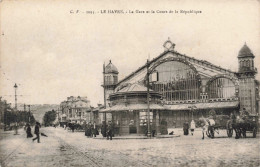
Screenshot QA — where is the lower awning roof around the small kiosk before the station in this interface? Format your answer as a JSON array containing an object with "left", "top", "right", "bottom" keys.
[{"left": 100, "top": 104, "right": 165, "bottom": 113}]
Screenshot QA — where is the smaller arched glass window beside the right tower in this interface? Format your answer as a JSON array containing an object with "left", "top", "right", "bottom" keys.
[{"left": 208, "top": 77, "right": 236, "bottom": 98}]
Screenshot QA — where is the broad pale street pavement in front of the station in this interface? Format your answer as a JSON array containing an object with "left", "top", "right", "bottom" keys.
[{"left": 0, "top": 127, "right": 260, "bottom": 167}]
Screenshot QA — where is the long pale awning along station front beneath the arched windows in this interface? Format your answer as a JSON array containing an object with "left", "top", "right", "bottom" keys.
[{"left": 164, "top": 101, "right": 239, "bottom": 110}]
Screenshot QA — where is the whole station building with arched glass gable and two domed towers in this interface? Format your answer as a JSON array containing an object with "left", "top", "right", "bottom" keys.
[{"left": 101, "top": 40, "right": 259, "bottom": 134}]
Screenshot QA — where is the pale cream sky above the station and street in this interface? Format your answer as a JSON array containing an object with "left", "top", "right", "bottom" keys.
[{"left": 0, "top": 0, "right": 260, "bottom": 106}]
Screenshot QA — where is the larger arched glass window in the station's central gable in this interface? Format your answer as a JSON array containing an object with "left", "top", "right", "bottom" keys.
[{"left": 149, "top": 61, "right": 199, "bottom": 101}]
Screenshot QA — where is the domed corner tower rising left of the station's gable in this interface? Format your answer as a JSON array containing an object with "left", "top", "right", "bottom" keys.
[{"left": 102, "top": 60, "right": 118, "bottom": 107}]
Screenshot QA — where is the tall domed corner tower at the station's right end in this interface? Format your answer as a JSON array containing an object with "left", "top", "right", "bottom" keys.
[{"left": 237, "top": 44, "right": 258, "bottom": 114}]
